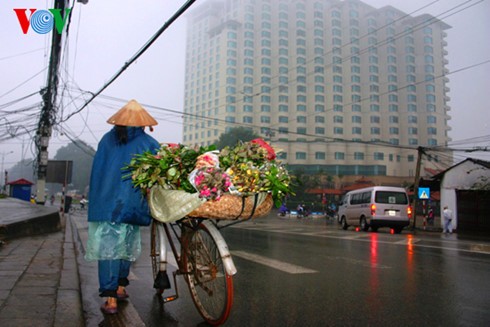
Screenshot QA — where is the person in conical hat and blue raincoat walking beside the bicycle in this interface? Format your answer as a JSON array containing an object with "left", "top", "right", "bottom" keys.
[{"left": 85, "top": 100, "right": 159, "bottom": 314}]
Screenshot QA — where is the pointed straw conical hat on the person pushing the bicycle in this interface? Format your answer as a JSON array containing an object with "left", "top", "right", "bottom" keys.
[{"left": 107, "top": 100, "right": 158, "bottom": 126}]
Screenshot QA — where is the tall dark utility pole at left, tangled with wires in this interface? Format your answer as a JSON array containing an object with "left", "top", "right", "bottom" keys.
[{"left": 35, "top": 0, "right": 68, "bottom": 204}]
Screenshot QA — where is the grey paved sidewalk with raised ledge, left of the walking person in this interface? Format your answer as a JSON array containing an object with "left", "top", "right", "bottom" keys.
[{"left": 0, "top": 198, "right": 84, "bottom": 327}]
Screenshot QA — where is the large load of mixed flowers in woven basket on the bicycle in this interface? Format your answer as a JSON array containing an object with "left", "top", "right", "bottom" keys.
[{"left": 125, "top": 139, "right": 292, "bottom": 222}]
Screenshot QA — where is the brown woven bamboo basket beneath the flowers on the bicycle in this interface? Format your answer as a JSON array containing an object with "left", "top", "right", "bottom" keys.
[{"left": 187, "top": 193, "right": 273, "bottom": 220}]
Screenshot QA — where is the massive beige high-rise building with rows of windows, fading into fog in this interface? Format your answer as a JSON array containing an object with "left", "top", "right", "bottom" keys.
[{"left": 183, "top": 0, "right": 450, "bottom": 183}]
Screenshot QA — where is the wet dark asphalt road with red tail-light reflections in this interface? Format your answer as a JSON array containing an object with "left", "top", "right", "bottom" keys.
[{"left": 72, "top": 217, "right": 490, "bottom": 326}]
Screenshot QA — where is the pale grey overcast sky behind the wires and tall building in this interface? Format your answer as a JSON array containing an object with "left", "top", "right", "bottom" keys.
[{"left": 0, "top": 0, "right": 490, "bottom": 168}]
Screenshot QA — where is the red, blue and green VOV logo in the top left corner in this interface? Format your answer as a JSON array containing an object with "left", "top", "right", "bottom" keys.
[{"left": 14, "top": 8, "right": 71, "bottom": 34}]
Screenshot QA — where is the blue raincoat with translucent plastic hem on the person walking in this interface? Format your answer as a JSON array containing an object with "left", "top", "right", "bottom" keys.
[{"left": 85, "top": 127, "right": 160, "bottom": 261}]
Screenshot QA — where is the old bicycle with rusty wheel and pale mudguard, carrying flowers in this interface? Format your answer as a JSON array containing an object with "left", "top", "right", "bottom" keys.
[{"left": 150, "top": 192, "right": 272, "bottom": 326}]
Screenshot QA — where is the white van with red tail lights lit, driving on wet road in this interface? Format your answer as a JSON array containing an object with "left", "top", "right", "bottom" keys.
[{"left": 338, "top": 186, "right": 412, "bottom": 233}]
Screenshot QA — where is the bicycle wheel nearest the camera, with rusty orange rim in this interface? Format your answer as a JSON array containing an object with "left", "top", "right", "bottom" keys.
[{"left": 182, "top": 223, "right": 233, "bottom": 326}]
